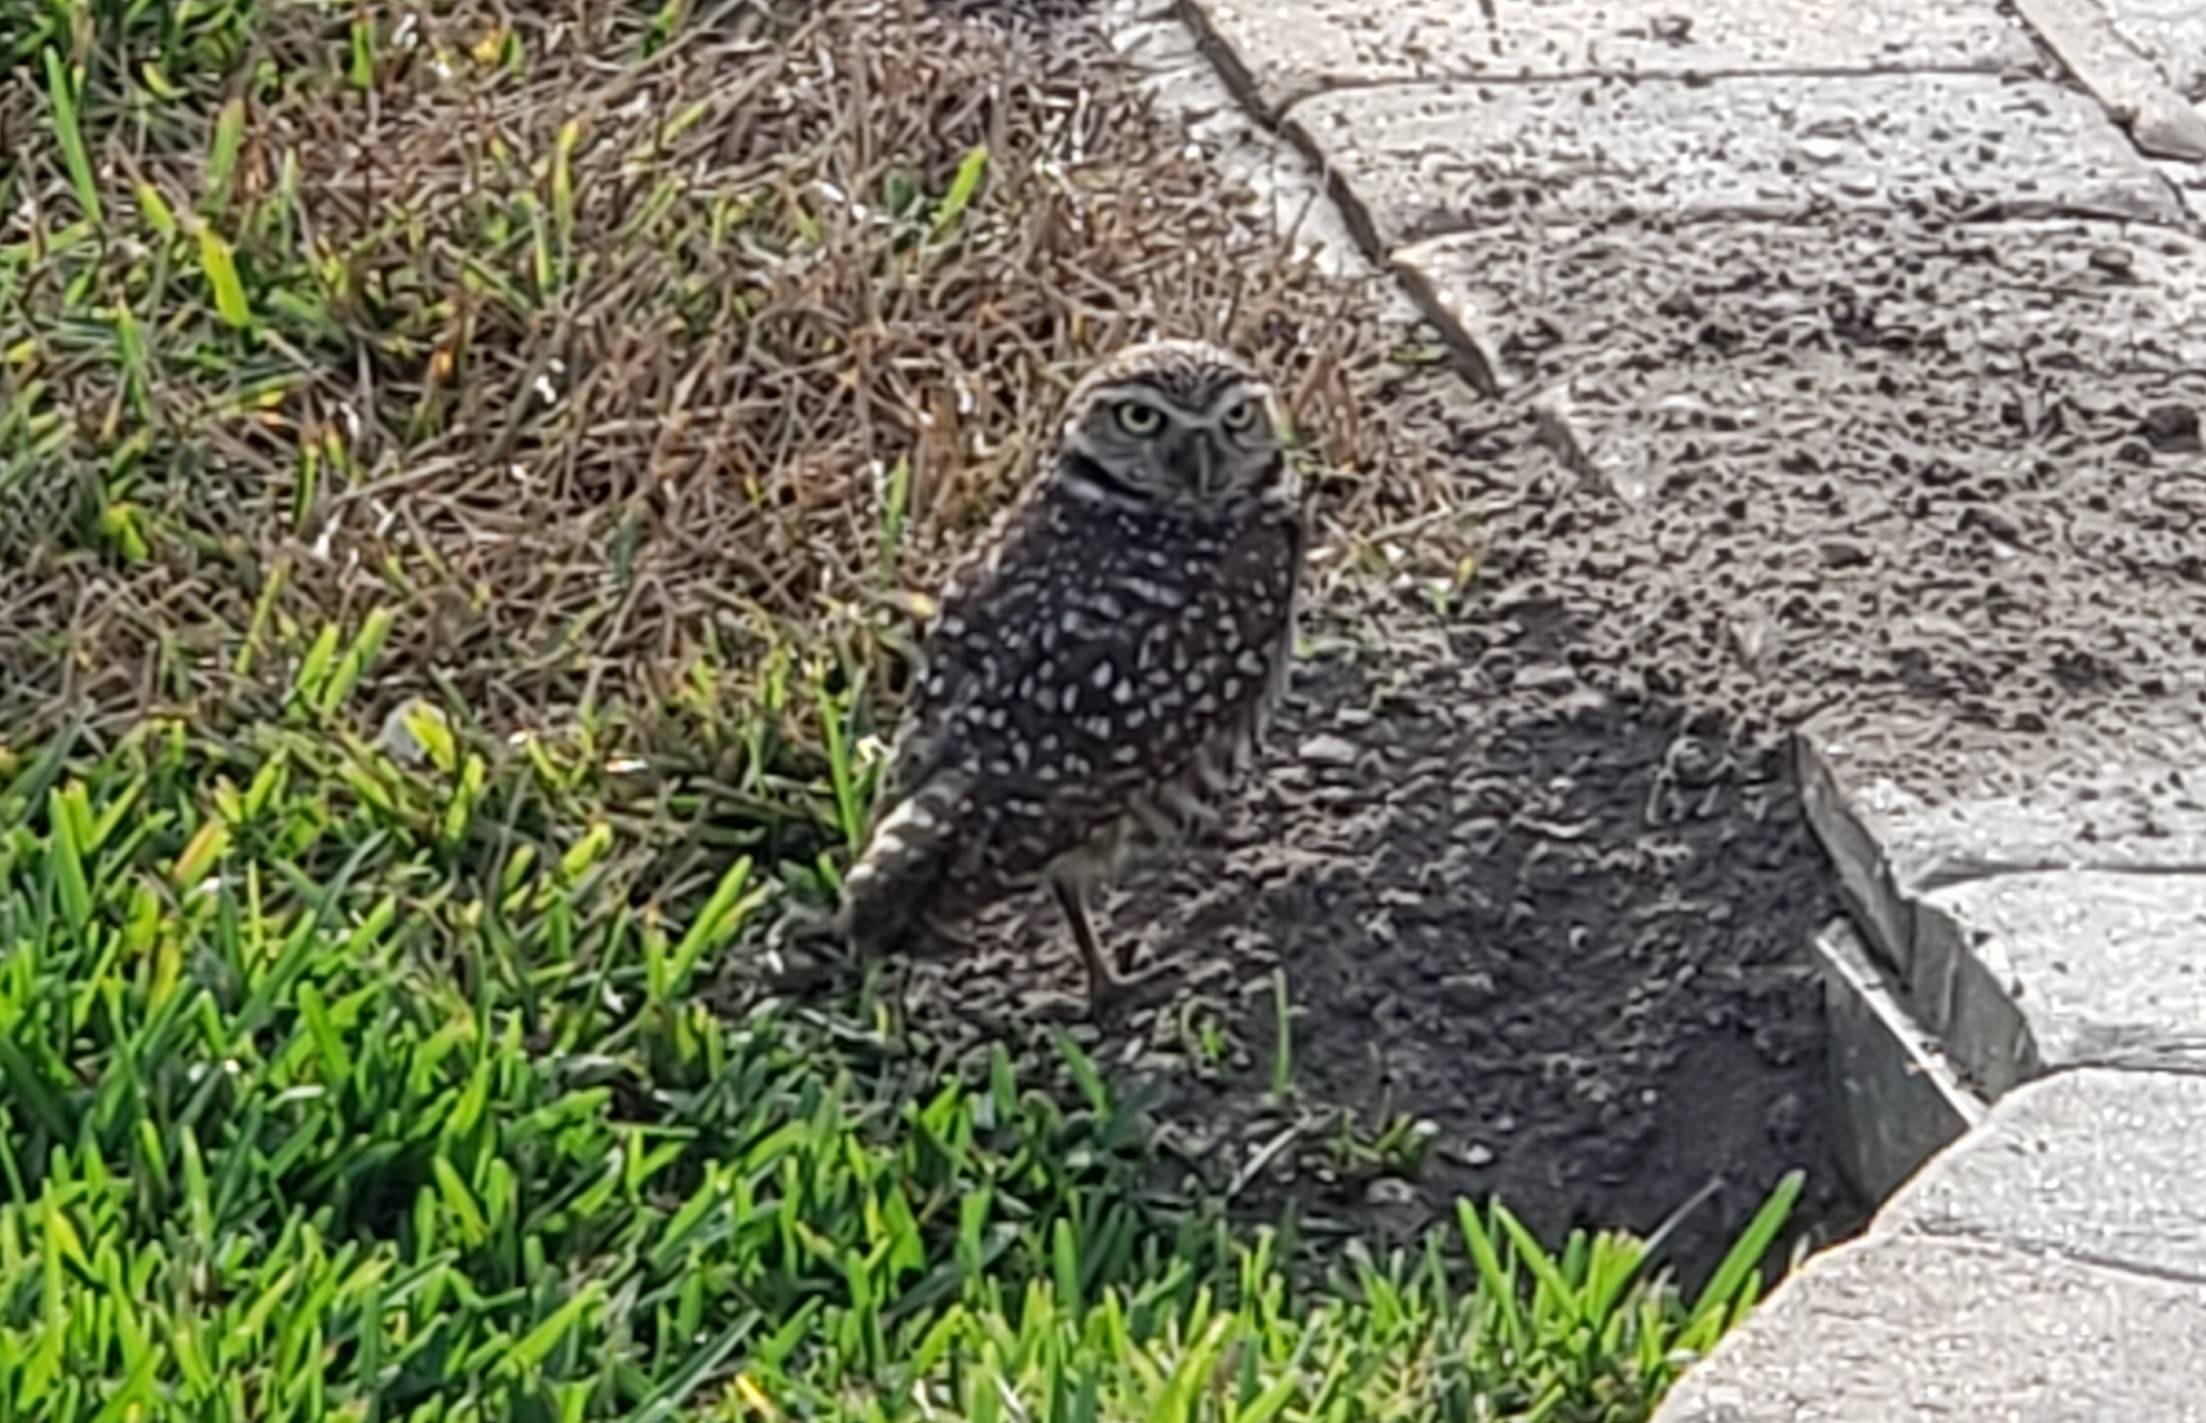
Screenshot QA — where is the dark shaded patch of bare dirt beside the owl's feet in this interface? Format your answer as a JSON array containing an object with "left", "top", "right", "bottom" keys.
[{"left": 895, "top": 582, "right": 1855, "bottom": 1280}]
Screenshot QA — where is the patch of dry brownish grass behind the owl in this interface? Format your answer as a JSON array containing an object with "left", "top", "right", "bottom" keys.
[{"left": 0, "top": 0, "right": 1464, "bottom": 842}]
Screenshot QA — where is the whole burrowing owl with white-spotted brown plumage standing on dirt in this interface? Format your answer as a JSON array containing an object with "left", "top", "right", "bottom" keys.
[{"left": 840, "top": 340, "right": 1306, "bottom": 1006}]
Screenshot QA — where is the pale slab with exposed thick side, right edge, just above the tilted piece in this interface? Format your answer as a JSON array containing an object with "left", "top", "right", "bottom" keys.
[{"left": 1908, "top": 871, "right": 2206, "bottom": 1096}]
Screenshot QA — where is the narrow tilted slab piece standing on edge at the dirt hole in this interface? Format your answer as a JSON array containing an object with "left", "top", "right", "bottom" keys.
[{"left": 1816, "top": 920, "right": 1983, "bottom": 1200}]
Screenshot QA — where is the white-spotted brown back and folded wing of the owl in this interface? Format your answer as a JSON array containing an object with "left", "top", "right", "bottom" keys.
[{"left": 845, "top": 476, "right": 1302, "bottom": 944}]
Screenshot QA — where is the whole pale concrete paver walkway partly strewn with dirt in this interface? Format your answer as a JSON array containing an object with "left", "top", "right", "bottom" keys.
[{"left": 1147, "top": 0, "right": 2206, "bottom": 1423}]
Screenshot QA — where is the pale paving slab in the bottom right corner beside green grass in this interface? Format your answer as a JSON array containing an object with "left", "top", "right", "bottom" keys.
[{"left": 1655, "top": 1233, "right": 2206, "bottom": 1423}]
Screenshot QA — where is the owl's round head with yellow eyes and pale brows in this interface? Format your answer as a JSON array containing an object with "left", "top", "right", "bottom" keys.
[{"left": 1061, "top": 340, "right": 1284, "bottom": 503}]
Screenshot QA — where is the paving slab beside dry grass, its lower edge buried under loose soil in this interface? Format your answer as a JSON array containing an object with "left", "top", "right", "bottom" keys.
[{"left": 1394, "top": 216, "right": 2206, "bottom": 401}]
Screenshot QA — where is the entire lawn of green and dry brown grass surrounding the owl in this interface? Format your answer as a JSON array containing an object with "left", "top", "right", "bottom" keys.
[{"left": 0, "top": 0, "right": 1798, "bottom": 1423}]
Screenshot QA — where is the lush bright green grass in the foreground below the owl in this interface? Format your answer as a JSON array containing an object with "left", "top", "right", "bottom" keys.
[{"left": 0, "top": 697, "right": 1796, "bottom": 1423}]
